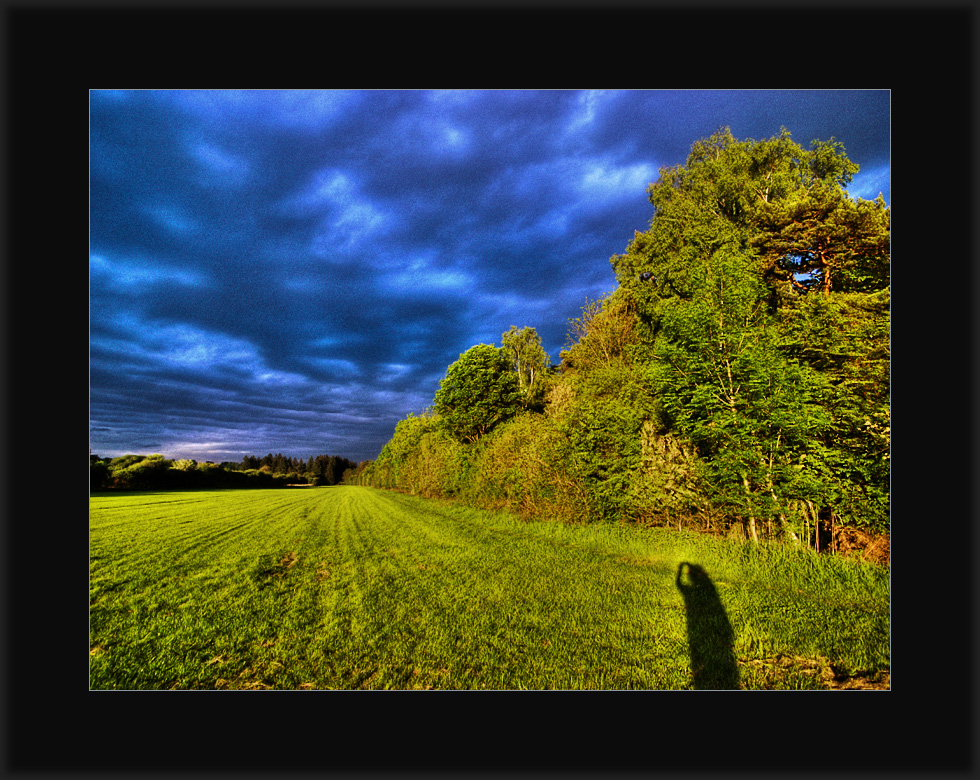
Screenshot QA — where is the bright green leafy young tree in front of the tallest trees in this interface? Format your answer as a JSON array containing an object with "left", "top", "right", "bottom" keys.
[{"left": 651, "top": 250, "right": 829, "bottom": 535}]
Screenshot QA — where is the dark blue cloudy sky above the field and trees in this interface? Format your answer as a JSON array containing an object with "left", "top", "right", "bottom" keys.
[{"left": 89, "top": 90, "right": 891, "bottom": 462}]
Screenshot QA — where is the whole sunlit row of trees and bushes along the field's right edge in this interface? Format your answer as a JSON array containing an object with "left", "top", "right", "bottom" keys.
[{"left": 349, "top": 128, "right": 890, "bottom": 548}]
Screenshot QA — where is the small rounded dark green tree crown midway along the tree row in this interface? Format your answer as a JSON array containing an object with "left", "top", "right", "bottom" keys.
[{"left": 434, "top": 344, "right": 521, "bottom": 442}]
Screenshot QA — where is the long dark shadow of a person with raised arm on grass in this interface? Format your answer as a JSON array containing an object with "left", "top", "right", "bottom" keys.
[{"left": 677, "top": 563, "right": 738, "bottom": 690}]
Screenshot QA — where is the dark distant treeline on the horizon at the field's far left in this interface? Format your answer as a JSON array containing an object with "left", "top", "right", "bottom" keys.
[{"left": 89, "top": 452, "right": 358, "bottom": 490}]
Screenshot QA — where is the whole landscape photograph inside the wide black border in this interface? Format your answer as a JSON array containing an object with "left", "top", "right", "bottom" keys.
[{"left": 83, "top": 88, "right": 892, "bottom": 692}]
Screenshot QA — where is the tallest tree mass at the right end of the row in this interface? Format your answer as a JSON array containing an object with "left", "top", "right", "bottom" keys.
[{"left": 612, "top": 128, "right": 890, "bottom": 536}]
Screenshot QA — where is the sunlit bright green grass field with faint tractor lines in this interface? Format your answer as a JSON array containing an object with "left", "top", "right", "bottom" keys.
[{"left": 90, "top": 487, "right": 890, "bottom": 689}]
